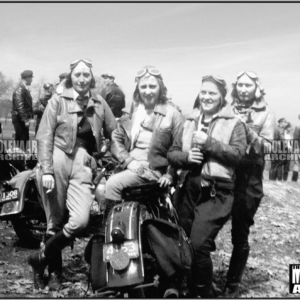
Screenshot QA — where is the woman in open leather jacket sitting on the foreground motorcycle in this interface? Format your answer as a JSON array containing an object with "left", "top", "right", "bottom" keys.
[{"left": 100, "top": 66, "right": 183, "bottom": 236}]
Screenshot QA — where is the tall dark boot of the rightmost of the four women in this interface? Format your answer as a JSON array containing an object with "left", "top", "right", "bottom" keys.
[{"left": 223, "top": 246, "right": 250, "bottom": 298}]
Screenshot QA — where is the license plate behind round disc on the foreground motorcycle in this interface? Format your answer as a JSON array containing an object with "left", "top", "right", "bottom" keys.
[{"left": 103, "top": 240, "right": 139, "bottom": 262}]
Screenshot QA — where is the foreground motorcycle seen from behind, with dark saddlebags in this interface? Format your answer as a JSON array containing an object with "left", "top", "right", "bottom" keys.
[{"left": 85, "top": 182, "right": 193, "bottom": 298}]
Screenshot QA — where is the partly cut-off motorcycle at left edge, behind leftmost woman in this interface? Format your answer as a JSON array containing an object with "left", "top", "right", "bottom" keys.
[{"left": 0, "top": 141, "right": 42, "bottom": 245}]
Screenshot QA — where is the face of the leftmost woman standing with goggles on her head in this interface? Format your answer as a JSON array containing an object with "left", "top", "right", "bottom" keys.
[{"left": 71, "top": 62, "right": 93, "bottom": 95}]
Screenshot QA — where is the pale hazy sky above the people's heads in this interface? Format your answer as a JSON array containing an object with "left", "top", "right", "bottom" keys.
[{"left": 0, "top": 3, "right": 300, "bottom": 124}]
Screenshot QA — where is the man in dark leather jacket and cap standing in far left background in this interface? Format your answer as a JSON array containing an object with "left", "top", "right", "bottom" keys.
[{"left": 11, "top": 70, "right": 33, "bottom": 151}]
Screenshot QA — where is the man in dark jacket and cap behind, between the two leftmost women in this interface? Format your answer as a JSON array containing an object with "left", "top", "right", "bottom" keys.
[{"left": 101, "top": 73, "right": 125, "bottom": 118}]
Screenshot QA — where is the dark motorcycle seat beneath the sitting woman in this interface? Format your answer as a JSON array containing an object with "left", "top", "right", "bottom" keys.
[{"left": 122, "top": 181, "right": 166, "bottom": 200}]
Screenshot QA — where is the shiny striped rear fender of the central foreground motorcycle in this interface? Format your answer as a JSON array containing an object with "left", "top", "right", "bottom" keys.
[{"left": 106, "top": 202, "right": 150, "bottom": 287}]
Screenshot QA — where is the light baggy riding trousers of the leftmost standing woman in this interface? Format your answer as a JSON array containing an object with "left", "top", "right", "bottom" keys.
[{"left": 37, "top": 146, "right": 94, "bottom": 237}]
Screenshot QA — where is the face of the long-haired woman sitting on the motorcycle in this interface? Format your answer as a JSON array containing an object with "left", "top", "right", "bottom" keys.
[{"left": 138, "top": 74, "right": 160, "bottom": 109}]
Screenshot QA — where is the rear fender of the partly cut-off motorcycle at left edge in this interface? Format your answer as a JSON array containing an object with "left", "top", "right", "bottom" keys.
[{"left": 0, "top": 170, "right": 34, "bottom": 220}]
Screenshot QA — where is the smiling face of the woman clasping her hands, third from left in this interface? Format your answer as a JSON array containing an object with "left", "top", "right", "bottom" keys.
[{"left": 199, "top": 81, "right": 222, "bottom": 115}]
